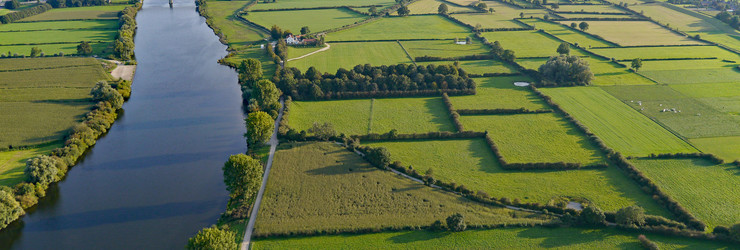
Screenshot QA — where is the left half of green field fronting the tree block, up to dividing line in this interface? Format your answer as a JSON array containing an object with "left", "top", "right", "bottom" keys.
[{"left": 288, "top": 99, "right": 371, "bottom": 135}]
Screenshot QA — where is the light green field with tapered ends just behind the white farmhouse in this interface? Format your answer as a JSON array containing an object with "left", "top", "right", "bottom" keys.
[{"left": 244, "top": 9, "right": 367, "bottom": 34}]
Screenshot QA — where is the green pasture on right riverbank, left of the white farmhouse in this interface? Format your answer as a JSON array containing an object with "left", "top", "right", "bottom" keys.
[{"left": 206, "top": 1, "right": 268, "bottom": 50}]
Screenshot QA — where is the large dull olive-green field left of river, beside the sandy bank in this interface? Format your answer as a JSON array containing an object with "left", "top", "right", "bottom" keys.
[{"left": 0, "top": 58, "right": 108, "bottom": 148}]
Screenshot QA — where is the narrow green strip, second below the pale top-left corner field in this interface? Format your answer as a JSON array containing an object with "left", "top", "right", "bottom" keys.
[{"left": 0, "top": 30, "right": 118, "bottom": 46}]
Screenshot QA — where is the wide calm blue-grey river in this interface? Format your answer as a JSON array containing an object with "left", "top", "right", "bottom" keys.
[{"left": 0, "top": 0, "right": 246, "bottom": 249}]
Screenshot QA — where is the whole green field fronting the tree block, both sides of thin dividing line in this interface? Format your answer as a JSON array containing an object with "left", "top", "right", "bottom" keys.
[{"left": 288, "top": 97, "right": 455, "bottom": 135}]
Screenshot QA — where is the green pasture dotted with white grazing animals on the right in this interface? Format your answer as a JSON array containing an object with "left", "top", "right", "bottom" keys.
[{"left": 604, "top": 86, "right": 740, "bottom": 138}]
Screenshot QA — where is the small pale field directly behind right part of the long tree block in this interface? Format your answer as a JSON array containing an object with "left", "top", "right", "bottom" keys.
[{"left": 401, "top": 40, "right": 491, "bottom": 58}]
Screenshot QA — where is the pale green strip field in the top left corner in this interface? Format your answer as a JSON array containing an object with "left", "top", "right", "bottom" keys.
[{"left": 18, "top": 5, "right": 128, "bottom": 22}]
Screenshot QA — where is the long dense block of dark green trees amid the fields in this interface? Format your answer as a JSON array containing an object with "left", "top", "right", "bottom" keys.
[{"left": 273, "top": 64, "right": 475, "bottom": 100}]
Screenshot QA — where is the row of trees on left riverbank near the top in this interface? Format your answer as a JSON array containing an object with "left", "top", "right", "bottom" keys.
[{"left": 113, "top": 3, "right": 141, "bottom": 61}]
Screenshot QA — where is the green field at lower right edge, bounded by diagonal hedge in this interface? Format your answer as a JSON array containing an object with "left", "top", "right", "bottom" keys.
[{"left": 632, "top": 159, "right": 740, "bottom": 229}]
